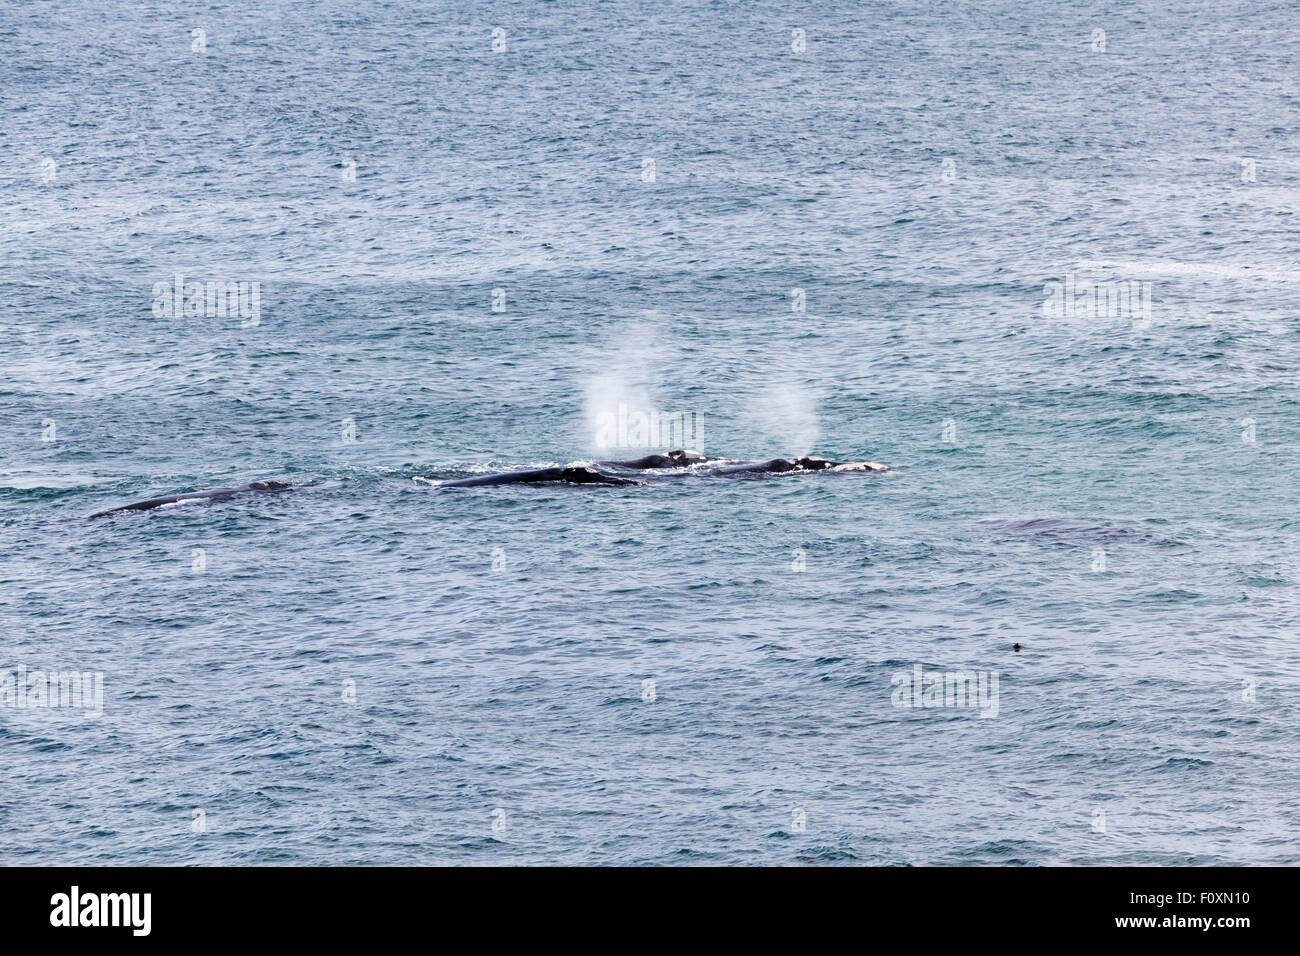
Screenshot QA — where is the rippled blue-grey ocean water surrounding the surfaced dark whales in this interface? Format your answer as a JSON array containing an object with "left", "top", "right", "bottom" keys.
[{"left": 0, "top": 0, "right": 1300, "bottom": 865}]
